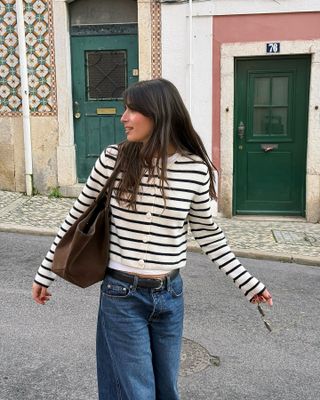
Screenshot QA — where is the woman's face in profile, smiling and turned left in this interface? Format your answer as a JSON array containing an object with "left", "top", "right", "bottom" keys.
[{"left": 121, "top": 106, "right": 154, "bottom": 142}]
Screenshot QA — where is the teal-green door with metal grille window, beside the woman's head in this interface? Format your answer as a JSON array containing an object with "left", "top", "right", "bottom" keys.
[{"left": 71, "top": 34, "right": 138, "bottom": 182}]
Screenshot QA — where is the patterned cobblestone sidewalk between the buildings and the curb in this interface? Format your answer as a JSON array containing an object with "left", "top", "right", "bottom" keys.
[{"left": 0, "top": 191, "right": 320, "bottom": 266}]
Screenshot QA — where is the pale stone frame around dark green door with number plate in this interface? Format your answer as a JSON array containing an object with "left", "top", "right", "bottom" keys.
[{"left": 220, "top": 40, "right": 320, "bottom": 222}]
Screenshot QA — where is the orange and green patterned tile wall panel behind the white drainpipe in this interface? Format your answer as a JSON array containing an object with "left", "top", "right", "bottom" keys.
[{"left": 0, "top": 0, "right": 56, "bottom": 116}]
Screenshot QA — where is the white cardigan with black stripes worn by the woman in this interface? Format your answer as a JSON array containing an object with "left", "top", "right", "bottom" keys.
[{"left": 35, "top": 145, "right": 265, "bottom": 300}]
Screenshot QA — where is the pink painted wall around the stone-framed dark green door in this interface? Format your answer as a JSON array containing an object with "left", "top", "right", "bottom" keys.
[{"left": 212, "top": 12, "right": 320, "bottom": 169}]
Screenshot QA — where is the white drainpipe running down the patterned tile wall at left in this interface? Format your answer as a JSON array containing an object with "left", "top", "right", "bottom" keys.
[{"left": 16, "top": 0, "right": 33, "bottom": 196}]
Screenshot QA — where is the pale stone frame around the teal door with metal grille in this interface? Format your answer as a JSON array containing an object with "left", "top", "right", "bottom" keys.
[{"left": 53, "top": 0, "right": 154, "bottom": 196}]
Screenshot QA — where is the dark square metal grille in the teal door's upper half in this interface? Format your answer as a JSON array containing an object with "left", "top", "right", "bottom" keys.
[{"left": 86, "top": 50, "right": 127, "bottom": 100}]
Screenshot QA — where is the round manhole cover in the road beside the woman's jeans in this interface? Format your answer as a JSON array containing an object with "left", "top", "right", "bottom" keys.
[{"left": 180, "top": 338, "right": 220, "bottom": 376}]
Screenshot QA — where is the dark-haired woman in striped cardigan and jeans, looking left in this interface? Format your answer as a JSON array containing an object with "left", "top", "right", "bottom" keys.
[{"left": 33, "top": 79, "right": 272, "bottom": 400}]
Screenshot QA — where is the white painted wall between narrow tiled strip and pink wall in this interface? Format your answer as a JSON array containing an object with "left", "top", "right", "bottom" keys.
[{"left": 162, "top": 4, "right": 212, "bottom": 156}]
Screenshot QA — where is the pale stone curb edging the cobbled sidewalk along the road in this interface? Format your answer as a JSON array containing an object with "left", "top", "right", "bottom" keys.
[{"left": 0, "top": 224, "right": 320, "bottom": 267}]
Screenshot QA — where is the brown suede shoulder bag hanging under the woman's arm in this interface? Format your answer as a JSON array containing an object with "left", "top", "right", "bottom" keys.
[{"left": 52, "top": 155, "right": 119, "bottom": 288}]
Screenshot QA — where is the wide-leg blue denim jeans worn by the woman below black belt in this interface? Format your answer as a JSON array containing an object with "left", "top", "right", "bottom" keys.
[{"left": 96, "top": 275, "right": 183, "bottom": 400}]
